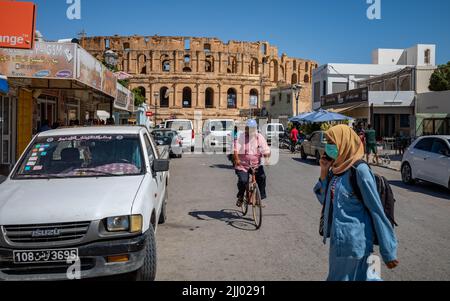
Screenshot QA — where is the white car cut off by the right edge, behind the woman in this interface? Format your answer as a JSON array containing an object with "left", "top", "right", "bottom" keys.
[{"left": 401, "top": 136, "right": 450, "bottom": 189}]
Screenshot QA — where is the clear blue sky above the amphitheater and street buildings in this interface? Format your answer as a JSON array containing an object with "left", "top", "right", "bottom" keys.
[{"left": 25, "top": 0, "right": 450, "bottom": 64}]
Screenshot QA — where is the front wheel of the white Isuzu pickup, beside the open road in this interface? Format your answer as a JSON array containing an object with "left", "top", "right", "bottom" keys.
[{"left": 132, "top": 225, "right": 156, "bottom": 281}]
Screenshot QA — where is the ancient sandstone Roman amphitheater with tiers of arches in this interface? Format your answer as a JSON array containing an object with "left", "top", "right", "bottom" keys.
[{"left": 81, "top": 36, "right": 317, "bottom": 122}]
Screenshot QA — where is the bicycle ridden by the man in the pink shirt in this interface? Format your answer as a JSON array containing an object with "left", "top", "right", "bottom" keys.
[{"left": 241, "top": 168, "right": 263, "bottom": 230}]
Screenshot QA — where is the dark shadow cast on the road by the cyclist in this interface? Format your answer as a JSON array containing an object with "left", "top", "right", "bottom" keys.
[{"left": 189, "top": 209, "right": 257, "bottom": 231}]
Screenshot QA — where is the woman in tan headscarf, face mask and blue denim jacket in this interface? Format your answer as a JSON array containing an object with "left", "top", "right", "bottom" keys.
[{"left": 314, "top": 125, "right": 398, "bottom": 281}]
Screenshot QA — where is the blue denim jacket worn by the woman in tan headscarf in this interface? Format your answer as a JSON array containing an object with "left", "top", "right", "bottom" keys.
[{"left": 314, "top": 164, "right": 397, "bottom": 262}]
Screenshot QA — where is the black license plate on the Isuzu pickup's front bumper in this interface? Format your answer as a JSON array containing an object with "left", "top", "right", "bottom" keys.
[{"left": 13, "top": 249, "right": 78, "bottom": 264}]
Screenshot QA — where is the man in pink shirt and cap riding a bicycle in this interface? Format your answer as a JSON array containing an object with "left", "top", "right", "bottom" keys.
[{"left": 234, "top": 119, "right": 270, "bottom": 207}]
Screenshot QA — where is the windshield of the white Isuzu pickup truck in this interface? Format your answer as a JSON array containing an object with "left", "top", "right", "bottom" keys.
[{"left": 13, "top": 135, "right": 145, "bottom": 179}]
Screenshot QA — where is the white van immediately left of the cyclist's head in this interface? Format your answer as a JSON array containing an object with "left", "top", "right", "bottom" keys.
[{"left": 203, "top": 119, "right": 235, "bottom": 151}]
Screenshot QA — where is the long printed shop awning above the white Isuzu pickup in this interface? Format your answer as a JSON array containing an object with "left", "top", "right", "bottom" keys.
[{"left": 0, "top": 42, "right": 134, "bottom": 112}]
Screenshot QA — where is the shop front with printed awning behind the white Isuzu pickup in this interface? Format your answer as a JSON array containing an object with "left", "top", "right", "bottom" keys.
[{"left": 0, "top": 42, "right": 131, "bottom": 173}]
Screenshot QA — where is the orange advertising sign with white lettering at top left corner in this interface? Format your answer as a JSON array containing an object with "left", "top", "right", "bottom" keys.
[{"left": 0, "top": 0, "right": 36, "bottom": 49}]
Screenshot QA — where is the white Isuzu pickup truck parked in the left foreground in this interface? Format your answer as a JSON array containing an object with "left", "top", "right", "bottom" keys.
[{"left": 0, "top": 127, "right": 169, "bottom": 280}]
